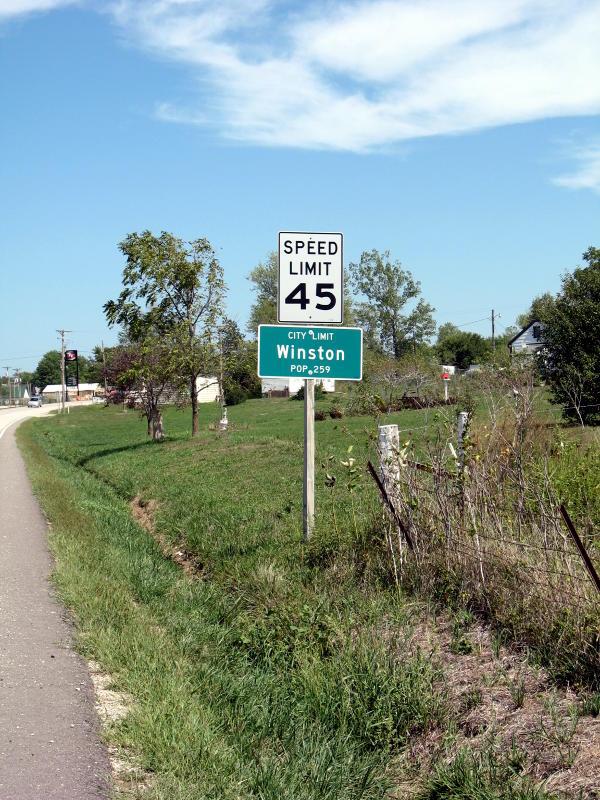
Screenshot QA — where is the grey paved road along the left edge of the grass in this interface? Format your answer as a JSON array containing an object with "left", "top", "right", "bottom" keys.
[{"left": 0, "top": 406, "right": 110, "bottom": 800}]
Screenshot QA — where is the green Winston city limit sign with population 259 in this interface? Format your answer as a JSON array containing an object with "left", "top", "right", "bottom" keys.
[{"left": 258, "top": 325, "right": 362, "bottom": 381}]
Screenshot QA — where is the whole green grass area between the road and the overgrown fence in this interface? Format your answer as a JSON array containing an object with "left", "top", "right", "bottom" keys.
[{"left": 18, "top": 400, "right": 580, "bottom": 800}]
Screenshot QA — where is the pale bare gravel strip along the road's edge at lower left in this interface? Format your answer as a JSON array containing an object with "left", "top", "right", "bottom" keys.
[{"left": 88, "top": 661, "right": 152, "bottom": 797}]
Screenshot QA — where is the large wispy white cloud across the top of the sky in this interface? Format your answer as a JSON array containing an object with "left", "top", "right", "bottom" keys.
[{"left": 108, "top": 0, "right": 600, "bottom": 151}]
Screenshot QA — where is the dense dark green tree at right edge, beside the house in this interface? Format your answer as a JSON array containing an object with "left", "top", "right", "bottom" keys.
[{"left": 542, "top": 247, "right": 600, "bottom": 425}]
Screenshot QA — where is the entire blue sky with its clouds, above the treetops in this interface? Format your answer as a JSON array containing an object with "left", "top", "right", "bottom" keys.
[{"left": 0, "top": 0, "right": 600, "bottom": 374}]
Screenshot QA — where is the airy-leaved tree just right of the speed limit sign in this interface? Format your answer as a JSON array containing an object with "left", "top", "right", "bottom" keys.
[{"left": 349, "top": 250, "right": 435, "bottom": 358}]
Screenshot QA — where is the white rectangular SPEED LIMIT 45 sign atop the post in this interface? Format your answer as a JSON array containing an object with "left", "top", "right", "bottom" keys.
[{"left": 277, "top": 232, "right": 344, "bottom": 325}]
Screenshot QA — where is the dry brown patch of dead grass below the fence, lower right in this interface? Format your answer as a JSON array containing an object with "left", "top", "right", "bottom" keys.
[{"left": 399, "top": 614, "right": 600, "bottom": 800}]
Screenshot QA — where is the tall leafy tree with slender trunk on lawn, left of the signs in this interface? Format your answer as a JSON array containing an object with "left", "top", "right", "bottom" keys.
[{"left": 104, "top": 231, "right": 225, "bottom": 436}]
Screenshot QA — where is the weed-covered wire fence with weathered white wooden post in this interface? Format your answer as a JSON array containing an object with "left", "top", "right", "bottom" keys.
[{"left": 369, "top": 368, "right": 600, "bottom": 682}]
